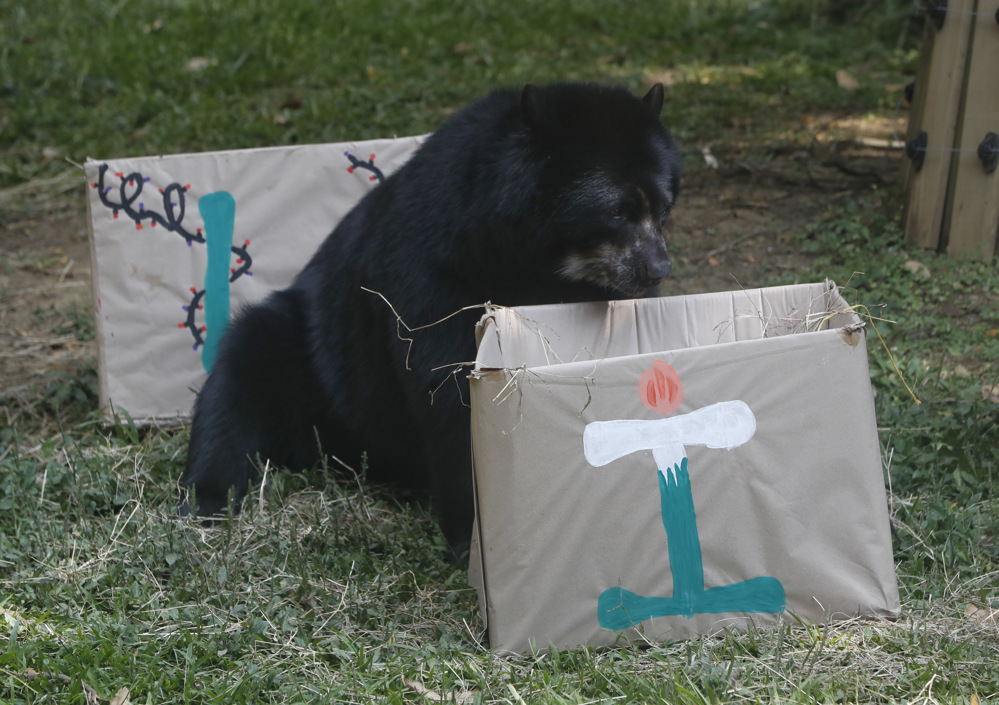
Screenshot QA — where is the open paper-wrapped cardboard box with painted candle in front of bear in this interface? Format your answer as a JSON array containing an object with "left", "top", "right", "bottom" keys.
[{"left": 469, "top": 282, "right": 899, "bottom": 652}]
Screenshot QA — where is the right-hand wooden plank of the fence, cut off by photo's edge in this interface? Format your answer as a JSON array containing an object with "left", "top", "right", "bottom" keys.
[{"left": 945, "top": 0, "right": 999, "bottom": 261}]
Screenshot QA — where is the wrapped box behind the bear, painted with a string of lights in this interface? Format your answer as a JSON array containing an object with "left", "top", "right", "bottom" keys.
[{"left": 85, "top": 137, "right": 424, "bottom": 422}]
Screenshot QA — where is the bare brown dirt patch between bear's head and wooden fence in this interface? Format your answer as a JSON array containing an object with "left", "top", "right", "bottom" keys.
[{"left": 663, "top": 140, "right": 902, "bottom": 295}]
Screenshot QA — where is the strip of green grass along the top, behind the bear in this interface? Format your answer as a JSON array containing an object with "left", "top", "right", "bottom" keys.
[{"left": 0, "top": 0, "right": 915, "bottom": 186}]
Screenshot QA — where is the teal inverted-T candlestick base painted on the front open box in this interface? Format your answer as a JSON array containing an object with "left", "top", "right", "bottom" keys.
[{"left": 597, "top": 458, "right": 787, "bottom": 630}]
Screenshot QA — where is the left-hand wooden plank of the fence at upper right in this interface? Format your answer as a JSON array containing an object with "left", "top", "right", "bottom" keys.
[{"left": 905, "top": 0, "right": 977, "bottom": 248}]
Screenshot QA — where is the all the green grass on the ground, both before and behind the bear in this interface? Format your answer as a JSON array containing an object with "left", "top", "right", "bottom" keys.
[{"left": 0, "top": 0, "right": 999, "bottom": 703}]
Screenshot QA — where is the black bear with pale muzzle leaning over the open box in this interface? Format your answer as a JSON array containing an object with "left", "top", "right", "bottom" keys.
[{"left": 182, "top": 84, "right": 680, "bottom": 555}]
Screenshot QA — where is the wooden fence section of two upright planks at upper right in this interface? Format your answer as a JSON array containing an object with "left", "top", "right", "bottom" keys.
[{"left": 905, "top": 0, "right": 999, "bottom": 261}]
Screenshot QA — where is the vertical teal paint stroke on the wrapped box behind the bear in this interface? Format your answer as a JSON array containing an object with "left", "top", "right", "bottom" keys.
[{"left": 198, "top": 191, "right": 236, "bottom": 372}]
